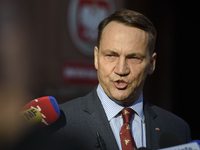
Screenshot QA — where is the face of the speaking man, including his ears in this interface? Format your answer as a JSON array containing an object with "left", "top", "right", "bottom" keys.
[{"left": 94, "top": 21, "right": 156, "bottom": 106}]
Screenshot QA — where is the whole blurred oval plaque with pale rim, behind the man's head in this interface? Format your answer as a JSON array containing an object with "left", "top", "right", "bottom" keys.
[{"left": 68, "top": 0, "right": 115, "bottom": 57}]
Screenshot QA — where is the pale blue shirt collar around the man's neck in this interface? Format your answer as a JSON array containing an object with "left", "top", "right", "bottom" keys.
[{"left": 97, "top": 84, "right": 144, "bottom": 122}]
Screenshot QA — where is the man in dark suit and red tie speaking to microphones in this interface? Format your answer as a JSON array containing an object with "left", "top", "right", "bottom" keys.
[{"left": 51, "top": 10, "right": 191, "bottom": 150}]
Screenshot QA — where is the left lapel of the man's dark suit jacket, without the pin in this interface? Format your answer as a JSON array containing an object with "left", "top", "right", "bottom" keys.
[{"left": 84, "top": 88, "right": 119, "bottom": 150}]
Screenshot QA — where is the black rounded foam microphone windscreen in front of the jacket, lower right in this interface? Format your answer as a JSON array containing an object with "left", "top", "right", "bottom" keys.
[{"left": 159, "top": 131, "right": 184, "bottom": 148}]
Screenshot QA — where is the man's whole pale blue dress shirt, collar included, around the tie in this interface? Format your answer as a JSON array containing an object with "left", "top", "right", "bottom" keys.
[{"left": 97, "top": 84, "right": 146, "bottom": 150}]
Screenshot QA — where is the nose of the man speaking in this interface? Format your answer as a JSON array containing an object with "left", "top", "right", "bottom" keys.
[{"left": 114, "top": 58, "right": 130, "bottom": 76}]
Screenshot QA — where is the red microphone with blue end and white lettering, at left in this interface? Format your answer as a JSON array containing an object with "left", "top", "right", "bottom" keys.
[{"left": 21, "top": 96, "right": 60, "bottom": 127}]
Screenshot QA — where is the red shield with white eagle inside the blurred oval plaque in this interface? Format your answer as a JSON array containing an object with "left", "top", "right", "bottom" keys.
[{"left": 77, "top": 0, "right": 110, "bottom": 44}]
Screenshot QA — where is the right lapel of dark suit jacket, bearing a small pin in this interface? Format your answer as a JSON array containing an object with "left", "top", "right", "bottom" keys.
[{"left": 144, "top": 102, "right": 162, "bottom": 150}]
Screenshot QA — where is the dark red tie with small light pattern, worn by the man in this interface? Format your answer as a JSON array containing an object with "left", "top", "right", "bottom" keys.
[{"left": 120, "top": 108, "right": 137, "bottom": 150}]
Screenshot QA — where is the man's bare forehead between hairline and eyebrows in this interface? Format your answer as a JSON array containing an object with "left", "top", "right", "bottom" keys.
[{"left": 100, "top": 21, "right": 149, "bottom": 53}]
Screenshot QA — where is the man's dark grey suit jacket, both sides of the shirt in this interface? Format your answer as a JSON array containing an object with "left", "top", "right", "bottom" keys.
[{"left": 45, "top": 88, "right": 191, "bottom": 150}]
